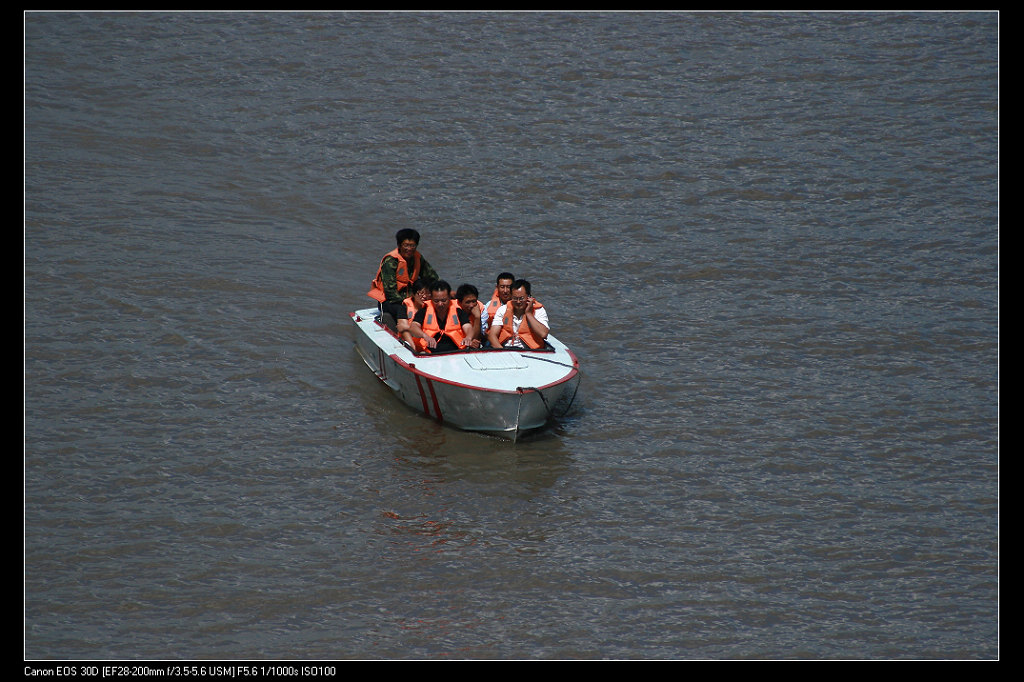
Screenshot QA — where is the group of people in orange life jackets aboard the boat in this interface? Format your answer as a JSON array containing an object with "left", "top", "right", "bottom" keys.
[{"left": 367, "top": 228, "right": 548, "bottom": 353}]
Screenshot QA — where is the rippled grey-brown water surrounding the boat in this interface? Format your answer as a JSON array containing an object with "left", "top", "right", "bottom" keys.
[{"left": 24, "top": 12, "right": 998, "bottom": 659}]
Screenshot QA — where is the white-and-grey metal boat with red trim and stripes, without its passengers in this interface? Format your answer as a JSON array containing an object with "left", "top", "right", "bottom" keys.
[{"left": 351, "top": 308, "right": 580, "bottom": 438}]
